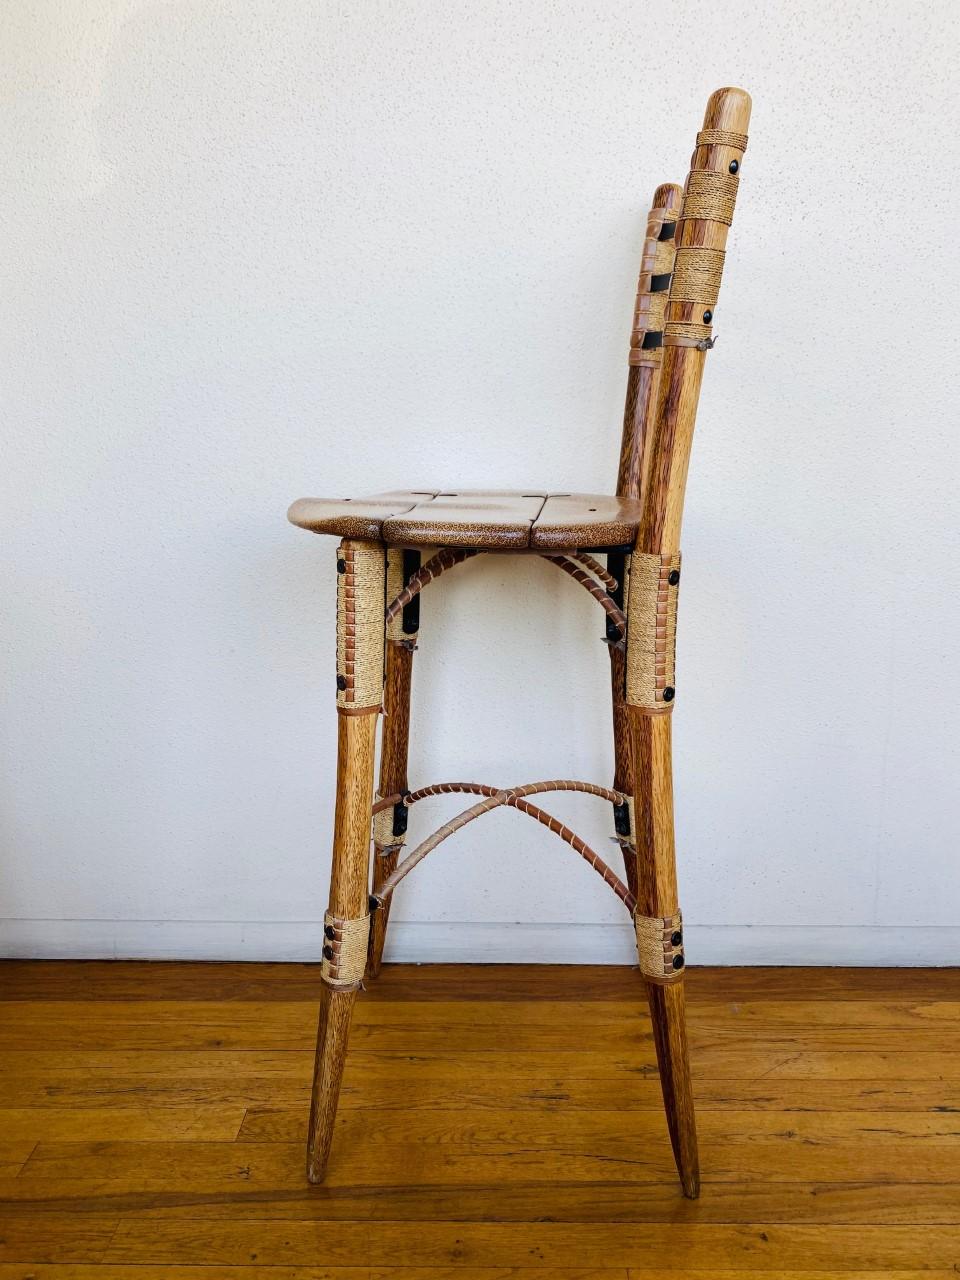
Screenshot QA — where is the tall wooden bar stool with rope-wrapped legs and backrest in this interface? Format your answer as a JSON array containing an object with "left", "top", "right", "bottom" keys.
[{"left": 289, "top": 88, "right": 750, "bottom": 1197}]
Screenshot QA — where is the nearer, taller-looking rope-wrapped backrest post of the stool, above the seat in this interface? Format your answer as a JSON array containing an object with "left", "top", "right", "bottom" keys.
[{"left": 637, "top": 88, "right": 750, "bottom": 553}]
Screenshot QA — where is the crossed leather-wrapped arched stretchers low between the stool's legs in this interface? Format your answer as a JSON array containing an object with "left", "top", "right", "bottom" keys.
[{"left": 371, "top": 780, "right": 636, "bottom": 913}]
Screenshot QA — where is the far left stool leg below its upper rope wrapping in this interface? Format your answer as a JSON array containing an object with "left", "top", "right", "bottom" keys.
[{"left": 366, "top": 639, "right": 413, "bottom": 978}]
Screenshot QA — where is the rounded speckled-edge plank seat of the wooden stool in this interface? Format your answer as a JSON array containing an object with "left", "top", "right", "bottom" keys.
[{"left": 288, "top": 489, "right": 640, "bottom": 552}]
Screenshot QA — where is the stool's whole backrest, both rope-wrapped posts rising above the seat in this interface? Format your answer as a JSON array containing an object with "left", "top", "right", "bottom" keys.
[{"left": 617, "top": 88, "right": 750, "bottom": 554}]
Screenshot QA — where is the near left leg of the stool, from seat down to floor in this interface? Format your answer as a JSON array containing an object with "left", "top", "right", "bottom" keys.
[{"left": 307, "top": 541, "right": 384, "bottom": 1183}]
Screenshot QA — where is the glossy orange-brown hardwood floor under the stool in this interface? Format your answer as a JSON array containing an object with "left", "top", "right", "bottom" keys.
[{"left": 0, "top": 961, "right": 960, "bottom": 1280}]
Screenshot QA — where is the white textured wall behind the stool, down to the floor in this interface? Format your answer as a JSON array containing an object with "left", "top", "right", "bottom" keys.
[{"left": 0, "top": 0, "right": 960, "bottom": 964}]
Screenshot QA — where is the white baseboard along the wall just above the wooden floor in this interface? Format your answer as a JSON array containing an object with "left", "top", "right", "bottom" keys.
[{"left": 0, "top": 919, "right": 960, "bottom": 966}]
